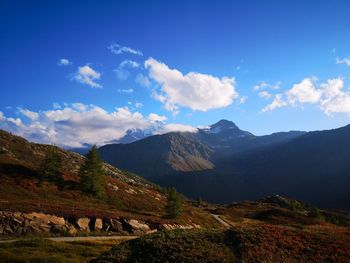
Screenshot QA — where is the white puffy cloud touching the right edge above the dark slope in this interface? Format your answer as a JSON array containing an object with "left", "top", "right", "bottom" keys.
[{"left": 262, "top": 78, "right": 350, "bottom": 116}]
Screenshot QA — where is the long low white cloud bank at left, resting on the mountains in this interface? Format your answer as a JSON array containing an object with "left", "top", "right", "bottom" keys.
[{"left": 0, "top": 103, "right": 196, "bottom": 147}]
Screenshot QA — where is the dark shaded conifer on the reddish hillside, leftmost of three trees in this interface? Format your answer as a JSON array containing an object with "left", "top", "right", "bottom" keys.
[{"left": 39, "top": 147, "right": 63, "bottom": 187}]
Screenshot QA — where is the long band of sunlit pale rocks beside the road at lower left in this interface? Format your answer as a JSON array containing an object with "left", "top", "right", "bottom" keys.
[{"left": 0, "top": 211, "right": 200, "bottom": 236}]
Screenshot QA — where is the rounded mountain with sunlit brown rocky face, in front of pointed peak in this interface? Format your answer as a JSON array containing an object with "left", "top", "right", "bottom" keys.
[{"left": 99, "top": 132, "right": 214, "bottom": 177}]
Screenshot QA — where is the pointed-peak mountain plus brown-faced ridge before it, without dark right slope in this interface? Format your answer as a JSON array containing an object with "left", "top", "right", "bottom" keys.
[{"left": 99, "top": 120, "right": 304, "bottom": 178}]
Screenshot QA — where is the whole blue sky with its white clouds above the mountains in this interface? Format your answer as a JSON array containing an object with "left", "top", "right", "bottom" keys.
[{"left": 0, "top": 1, "right": 350, "bottom": 146}]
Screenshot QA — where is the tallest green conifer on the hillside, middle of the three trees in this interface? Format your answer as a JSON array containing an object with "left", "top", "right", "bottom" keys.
[{"left": 80, "top": 145, "right": 105, "bottom": 198}]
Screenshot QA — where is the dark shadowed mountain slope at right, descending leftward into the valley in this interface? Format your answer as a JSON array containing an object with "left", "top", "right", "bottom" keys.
[{"left": 152, "top": 125, "right": 350, "bottom": 210}]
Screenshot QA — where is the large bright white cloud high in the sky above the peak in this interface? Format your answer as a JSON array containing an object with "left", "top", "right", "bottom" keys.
[{"left": 145, "top": 58, "right": 239, "bottom": 113}]
